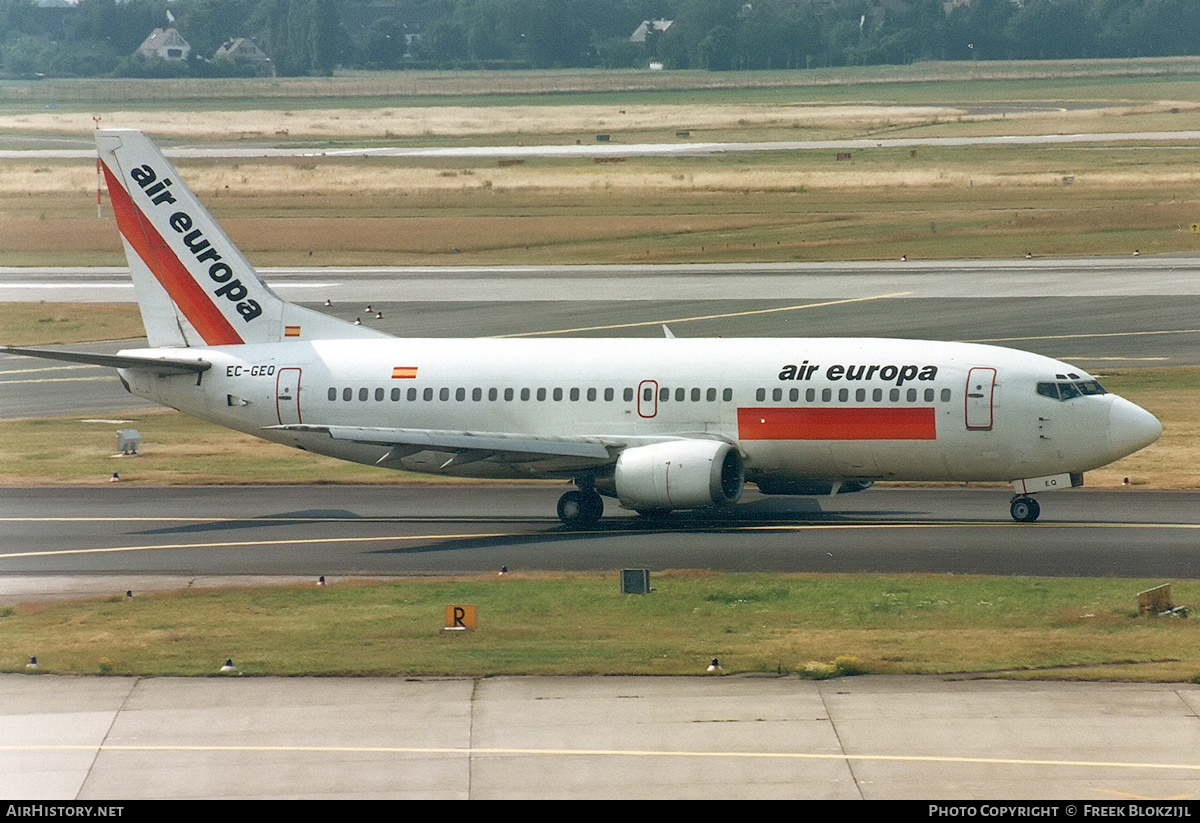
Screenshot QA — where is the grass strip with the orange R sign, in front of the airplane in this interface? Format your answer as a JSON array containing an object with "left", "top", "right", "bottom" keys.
[{"left": 0, "top": 571, "right": 1200, "bottom": 680}]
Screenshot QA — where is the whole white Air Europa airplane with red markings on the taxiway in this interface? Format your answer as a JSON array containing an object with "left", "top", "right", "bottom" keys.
[{"left": 0, "top": 130, "right": 1162, "bottom": 528}]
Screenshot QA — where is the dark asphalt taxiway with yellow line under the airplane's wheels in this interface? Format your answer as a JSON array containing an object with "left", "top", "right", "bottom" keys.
[{"left": 0, "top": 483, "right": 1200, "bottom": 587}]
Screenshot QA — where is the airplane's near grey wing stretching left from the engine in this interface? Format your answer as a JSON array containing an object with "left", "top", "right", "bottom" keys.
[{"left": 270, "top": 423, "right": 700, "bottom": 471}]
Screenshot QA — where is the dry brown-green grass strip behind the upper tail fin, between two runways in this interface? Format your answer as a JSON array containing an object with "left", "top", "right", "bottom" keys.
[{"left": 0, "top": 144, "right": 1200, "bottom": 266}]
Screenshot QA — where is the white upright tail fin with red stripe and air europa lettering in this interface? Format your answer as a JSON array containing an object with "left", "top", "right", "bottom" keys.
[{"left": 96, "top": 130, "right": 388, "bottom": 347}]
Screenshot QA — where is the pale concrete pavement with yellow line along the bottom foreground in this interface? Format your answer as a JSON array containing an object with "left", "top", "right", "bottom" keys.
[{"left": 0, "top": 674, "right": 1200, "bottom": 803}]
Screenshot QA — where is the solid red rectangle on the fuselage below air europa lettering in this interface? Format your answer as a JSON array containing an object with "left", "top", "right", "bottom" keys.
[{"left": 738, "top": 407, "right": 937, "bottom": 440}]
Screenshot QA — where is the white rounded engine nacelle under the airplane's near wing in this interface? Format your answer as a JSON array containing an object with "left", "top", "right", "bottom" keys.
[{"left": 612, "top": 440, "right": 745, "bottom": 511}]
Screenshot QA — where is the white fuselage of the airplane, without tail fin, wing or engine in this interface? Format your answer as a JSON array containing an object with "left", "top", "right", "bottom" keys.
[{"left": 122, "top": 338, "right": 1162, "bottom": 481}]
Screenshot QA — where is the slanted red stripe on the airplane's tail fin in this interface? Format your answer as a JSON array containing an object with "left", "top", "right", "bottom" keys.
[{"left": 103, "top": 163, "right": 245, "bottom": 346}]
